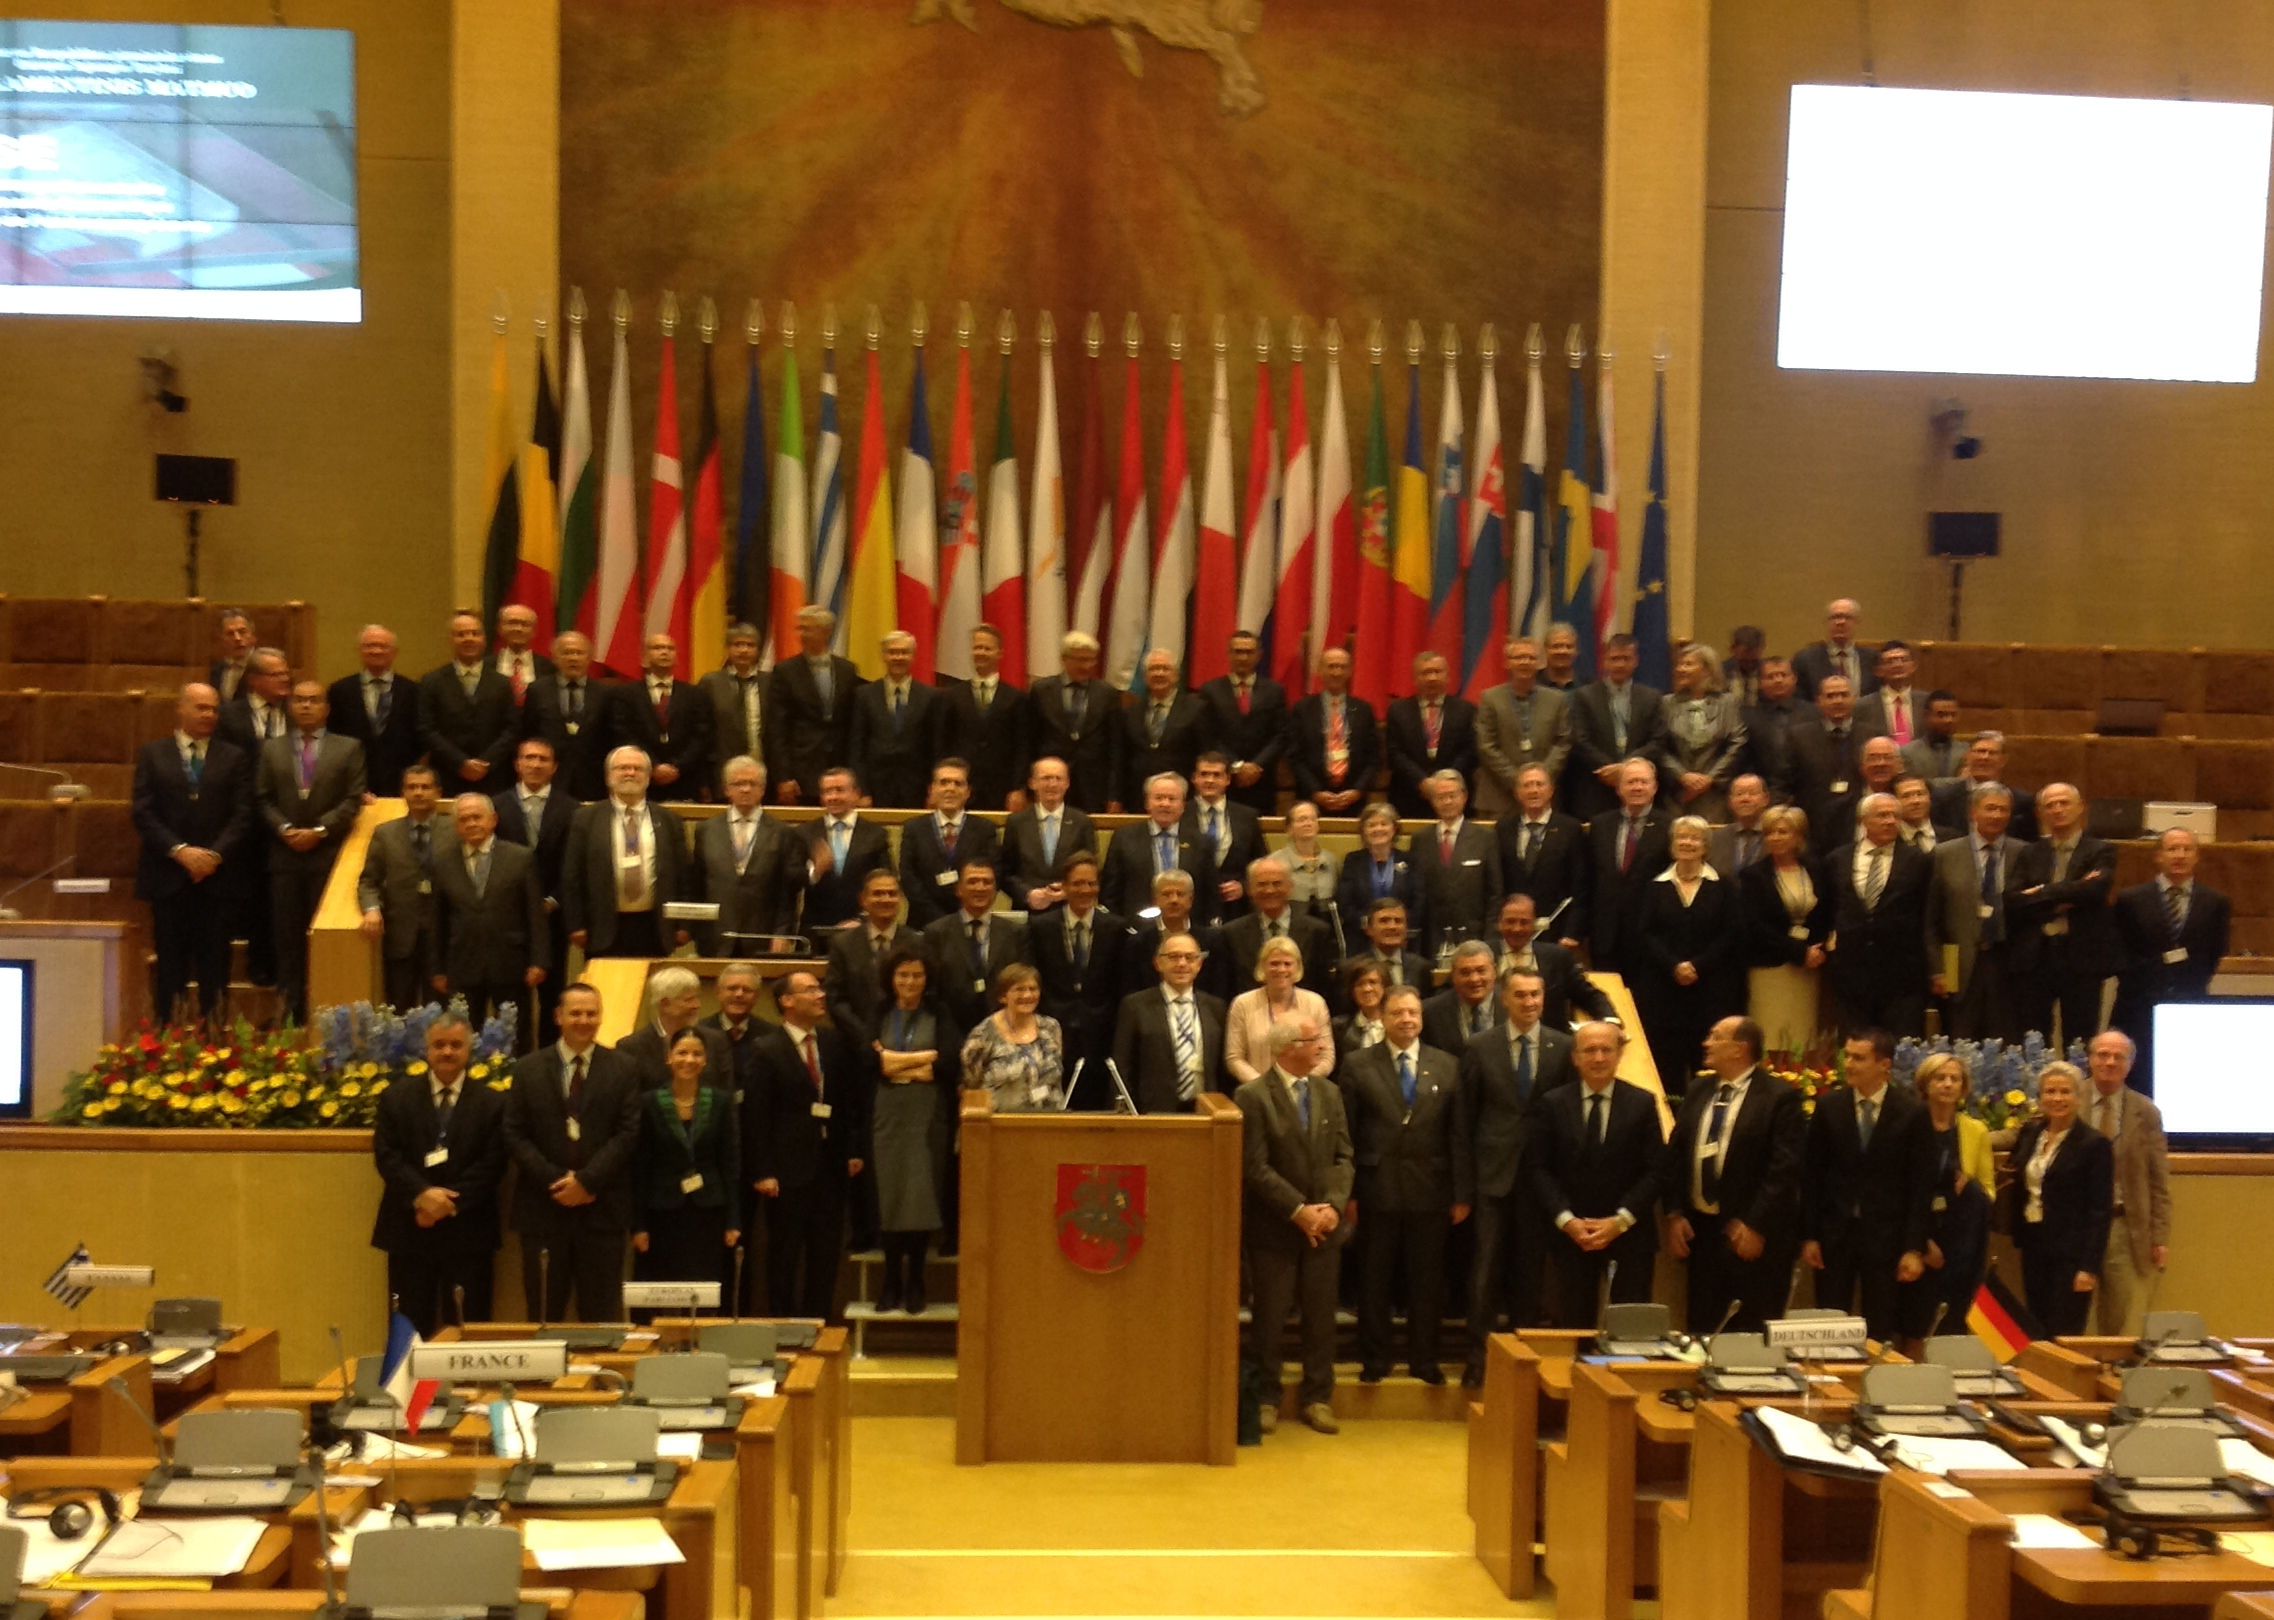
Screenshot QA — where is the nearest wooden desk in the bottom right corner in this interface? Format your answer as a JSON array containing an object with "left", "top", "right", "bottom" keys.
[{"left": 1824, "top": 1468, "right": 2274, "bottom": 1620}]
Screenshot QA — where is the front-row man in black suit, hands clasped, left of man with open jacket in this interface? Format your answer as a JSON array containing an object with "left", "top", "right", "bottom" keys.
[{"left": 1524, "top": 1019, "right": 1667, "bottom": 1329}]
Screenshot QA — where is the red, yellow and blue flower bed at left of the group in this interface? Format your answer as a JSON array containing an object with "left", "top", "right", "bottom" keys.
[{"left": 52, "top": 1001, "right": 514, "bottom": 1131}]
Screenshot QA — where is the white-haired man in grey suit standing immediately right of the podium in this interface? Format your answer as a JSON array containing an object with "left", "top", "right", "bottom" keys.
[{"left": 1233, "top": 1017, "right": 1355, "bottom": 1433}]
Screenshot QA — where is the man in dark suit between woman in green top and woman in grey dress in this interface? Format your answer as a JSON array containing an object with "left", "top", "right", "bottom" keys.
[{"left": 741, "top": 967, "right": 871, "bottom": 1320}]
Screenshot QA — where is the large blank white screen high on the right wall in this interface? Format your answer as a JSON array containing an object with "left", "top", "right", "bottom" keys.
[{"left": 1776, "top": 84, "right": 2274, "bottom": 382}]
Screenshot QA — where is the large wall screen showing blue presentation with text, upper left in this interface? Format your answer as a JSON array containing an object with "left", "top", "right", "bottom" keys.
[{"left": 0, "top": 20, "right": 364, "bottom": 323}]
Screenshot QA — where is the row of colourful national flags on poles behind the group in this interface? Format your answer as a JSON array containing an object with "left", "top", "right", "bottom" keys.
[{"left": 482, "top": 304, "right": 1671, "bottom": 705}]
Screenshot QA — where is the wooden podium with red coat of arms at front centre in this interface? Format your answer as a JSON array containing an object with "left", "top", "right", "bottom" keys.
[{"left": 955, "top": 1092, "right": 1242, "bottom": 1465}]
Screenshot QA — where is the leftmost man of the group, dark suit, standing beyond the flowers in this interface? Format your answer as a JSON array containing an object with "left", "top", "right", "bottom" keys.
[{"left": 134, "top": 683, "right": 252, "bottom": 1022}]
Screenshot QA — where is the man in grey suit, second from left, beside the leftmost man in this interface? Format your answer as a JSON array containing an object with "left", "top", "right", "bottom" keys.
[{"left": 255, "top": 680, "right": 364, "bottom": 1024}]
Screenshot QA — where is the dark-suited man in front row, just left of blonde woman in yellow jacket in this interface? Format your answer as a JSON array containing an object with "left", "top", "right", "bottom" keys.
[{"left": 1801, "top": 1028, "right": 1935, "bottom": 1345}]
